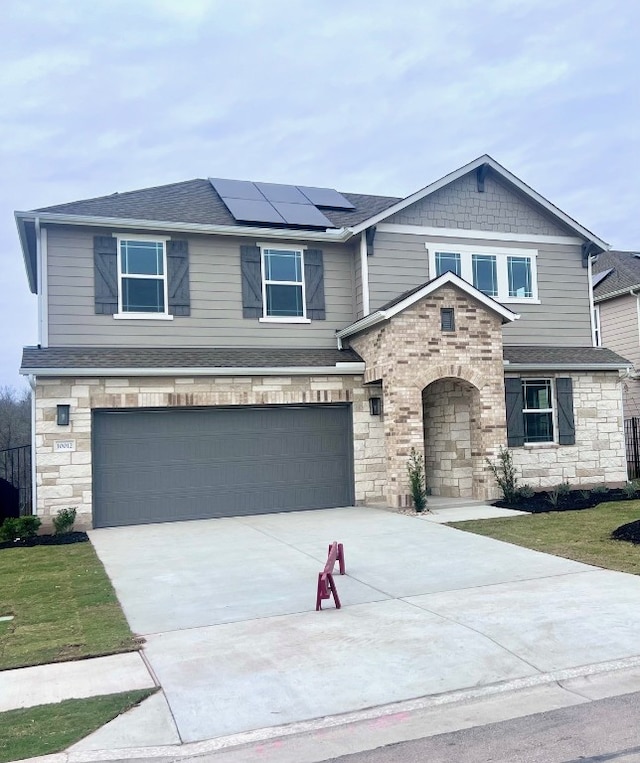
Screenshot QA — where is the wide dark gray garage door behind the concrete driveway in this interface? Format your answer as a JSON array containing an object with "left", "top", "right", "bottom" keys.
[{"left": 93, "top": 405, "right": 353, "bottom": 527}]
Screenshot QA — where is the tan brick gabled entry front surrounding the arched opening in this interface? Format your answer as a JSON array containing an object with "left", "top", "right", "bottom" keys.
[{"left": 350, "top": 286, "right": 506, "bottom": 506}]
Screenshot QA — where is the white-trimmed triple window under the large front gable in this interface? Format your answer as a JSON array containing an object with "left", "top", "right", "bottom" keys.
[{"left": 426, "top": 243, "right": 538, "bottom": 302}]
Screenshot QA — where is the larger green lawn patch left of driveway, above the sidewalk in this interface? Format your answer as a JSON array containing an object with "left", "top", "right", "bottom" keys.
[{"left": 0, "top": 543, "right": 137, "bottom": 670}]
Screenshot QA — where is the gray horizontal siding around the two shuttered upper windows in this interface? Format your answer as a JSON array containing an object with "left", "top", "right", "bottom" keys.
[{"left": 48, "top": 227, "right": 355, "bottom": 347}]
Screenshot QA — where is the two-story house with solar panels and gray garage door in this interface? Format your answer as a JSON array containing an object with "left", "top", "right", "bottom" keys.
[{"left": 16, "top": 156, "right": 628, "bottom": 526}]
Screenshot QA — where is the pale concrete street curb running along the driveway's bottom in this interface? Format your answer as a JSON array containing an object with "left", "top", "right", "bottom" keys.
[{"left": 20, "top": 655, "right": 640, "bottom": 763}]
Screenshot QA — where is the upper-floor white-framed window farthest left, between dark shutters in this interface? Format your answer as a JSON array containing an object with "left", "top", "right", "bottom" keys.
[{"left": 118, "top": 238, "right": 167, "bottom": 315}]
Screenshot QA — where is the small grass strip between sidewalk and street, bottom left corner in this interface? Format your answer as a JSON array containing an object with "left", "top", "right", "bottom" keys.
[{"left": 0, "top": 689, "right": 155, "bottom": 763}]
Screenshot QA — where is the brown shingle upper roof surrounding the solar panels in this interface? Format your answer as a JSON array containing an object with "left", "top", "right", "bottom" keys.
[{"left": 34, "top": 179, "right": 399, "bottom": 228}]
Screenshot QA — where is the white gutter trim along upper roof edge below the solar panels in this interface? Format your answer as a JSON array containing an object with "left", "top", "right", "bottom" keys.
[{"left": 15, "top": 212, "right": 352, "bottom": 243}]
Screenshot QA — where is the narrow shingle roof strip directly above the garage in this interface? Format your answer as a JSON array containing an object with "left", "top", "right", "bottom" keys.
[{"left": 21, "top": 347, "right": 362, "bottom": 372}]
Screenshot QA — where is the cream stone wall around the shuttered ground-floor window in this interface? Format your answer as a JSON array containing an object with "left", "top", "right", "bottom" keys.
[{"left": 507, "top": 372, "right": 627, "bottom": 488}]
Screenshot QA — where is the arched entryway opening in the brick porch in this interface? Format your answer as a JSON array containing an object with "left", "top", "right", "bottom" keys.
[{"left": 422, "top": 378, "right": 482, "bottom": 498}]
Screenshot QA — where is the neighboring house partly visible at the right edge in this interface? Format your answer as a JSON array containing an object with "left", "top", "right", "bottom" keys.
[{"left": 592, "top": 251, "right": 640, "bottom": 418}]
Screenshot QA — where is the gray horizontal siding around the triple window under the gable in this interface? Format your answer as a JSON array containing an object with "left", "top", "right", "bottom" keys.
[{"left": 369, "top": 233, "right": 592, "bottom": 346}]
